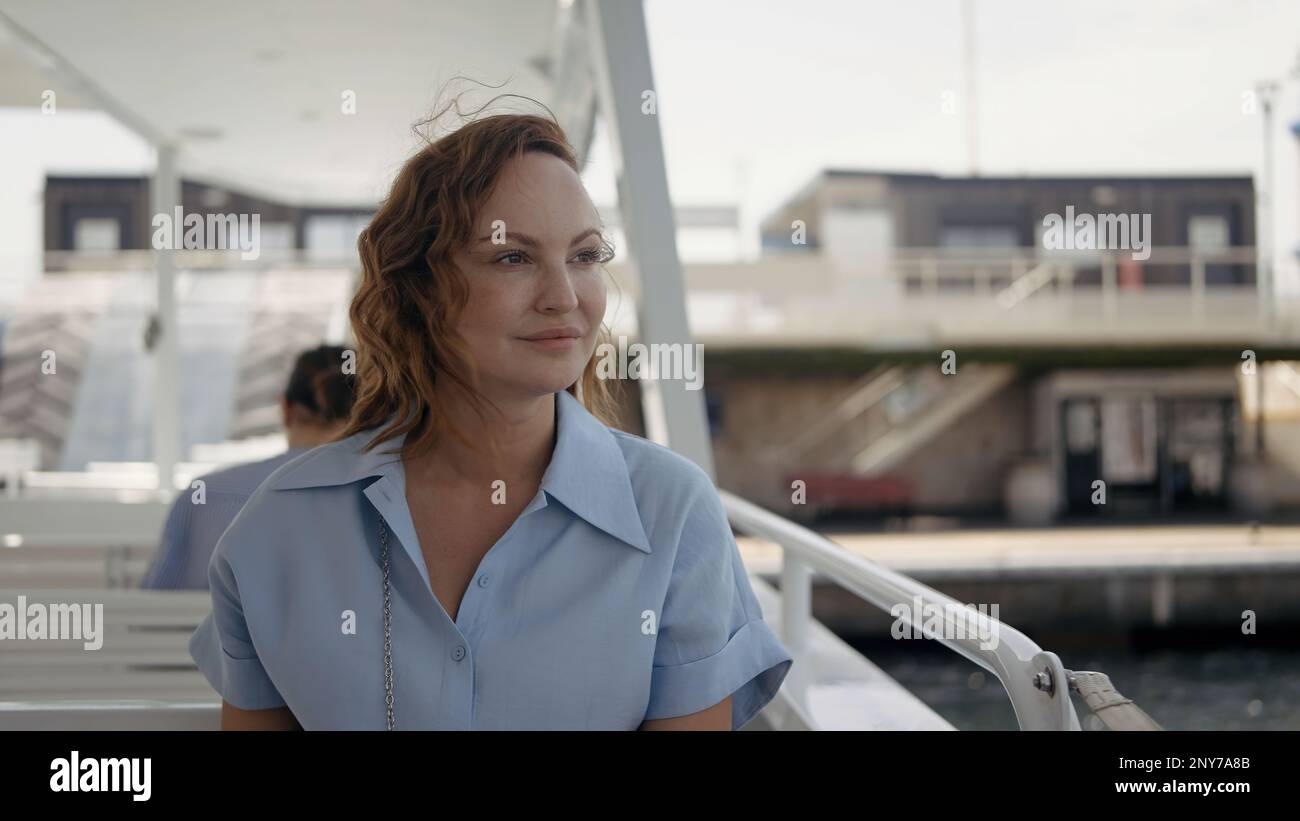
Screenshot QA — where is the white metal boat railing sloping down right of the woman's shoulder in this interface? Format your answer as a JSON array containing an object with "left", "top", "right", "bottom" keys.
[{"left": 720, "top": 491, "right": 1080, "bottom": 730}]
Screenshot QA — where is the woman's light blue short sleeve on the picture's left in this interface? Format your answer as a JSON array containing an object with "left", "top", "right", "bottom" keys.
[{"left": 190, "top": 544, "right": 285, "bottom": 709}]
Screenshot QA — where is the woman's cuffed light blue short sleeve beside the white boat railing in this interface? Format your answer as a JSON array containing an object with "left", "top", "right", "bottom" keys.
[{"left": 645, "top": 483, "right": 793, "bottom": 730}]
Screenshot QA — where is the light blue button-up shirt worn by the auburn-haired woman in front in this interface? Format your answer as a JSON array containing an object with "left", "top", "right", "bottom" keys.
[{"left": 190, "top": 391, "right": 793, "bottom": 730}]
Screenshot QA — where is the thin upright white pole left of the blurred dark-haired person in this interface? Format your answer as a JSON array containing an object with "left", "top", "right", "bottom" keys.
[{"left": 150, "top": 144, "right": 181, "bottom": 495}]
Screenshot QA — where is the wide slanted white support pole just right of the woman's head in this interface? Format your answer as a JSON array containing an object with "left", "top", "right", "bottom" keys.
[{"left": 582, "top": 0, "right": 715, "bottom": 477}]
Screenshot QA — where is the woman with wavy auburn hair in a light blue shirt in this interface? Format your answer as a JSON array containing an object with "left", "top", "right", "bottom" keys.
[{"left": 190, "top": 107, "right": 792, "bottom": 730}]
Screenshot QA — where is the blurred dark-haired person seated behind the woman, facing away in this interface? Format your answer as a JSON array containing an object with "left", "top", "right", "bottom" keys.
[{"left": 140, "top": 346, "right": 355, "bottom": 590}]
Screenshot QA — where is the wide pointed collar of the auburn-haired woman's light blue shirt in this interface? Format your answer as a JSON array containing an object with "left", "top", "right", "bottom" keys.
[{"left": 268, "top": 391, "right": 650, "bottom": 553}]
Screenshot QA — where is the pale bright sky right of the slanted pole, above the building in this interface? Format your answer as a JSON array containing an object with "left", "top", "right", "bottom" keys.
[{"left": 629, "top": 0, "right": 1300, "bottom": 214}]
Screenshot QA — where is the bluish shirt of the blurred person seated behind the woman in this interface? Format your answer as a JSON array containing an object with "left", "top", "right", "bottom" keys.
[{"left": 140, "top": 448, "right": 307, "bottom": 590}]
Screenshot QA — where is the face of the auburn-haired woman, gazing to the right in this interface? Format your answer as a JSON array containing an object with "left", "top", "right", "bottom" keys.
[{"left": 452, "top": 152, "right": 606, "bottom": 401}]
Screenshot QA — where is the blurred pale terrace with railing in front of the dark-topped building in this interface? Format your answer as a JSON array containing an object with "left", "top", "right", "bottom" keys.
[{"left": 595, "top": 247, "right": 1284, "bottom": 337}]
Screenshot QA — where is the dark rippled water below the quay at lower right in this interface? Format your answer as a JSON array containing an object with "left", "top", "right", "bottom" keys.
[{"left": 850, "top": 640, "right": 1300, "bottom": 730}]
